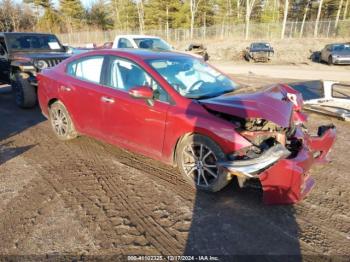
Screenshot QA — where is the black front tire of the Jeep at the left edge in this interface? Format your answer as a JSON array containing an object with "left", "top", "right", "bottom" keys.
[{"left": 11, "top": 73, "right": 37, "bottom": 108}]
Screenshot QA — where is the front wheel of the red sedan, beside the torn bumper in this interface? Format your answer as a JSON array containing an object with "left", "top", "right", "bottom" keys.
[{"left": 176, "top": 134, "right": 229, "bottom": 192}]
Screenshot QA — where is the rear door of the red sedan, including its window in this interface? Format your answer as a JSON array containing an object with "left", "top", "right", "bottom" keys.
[{"left": 59, "top": 55, "right": 105, "bottom": 138}]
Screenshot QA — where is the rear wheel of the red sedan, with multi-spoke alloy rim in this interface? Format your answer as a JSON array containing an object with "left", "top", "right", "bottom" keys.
[{"left": 49, "top": 101, "right": 78, "bottom": 141}]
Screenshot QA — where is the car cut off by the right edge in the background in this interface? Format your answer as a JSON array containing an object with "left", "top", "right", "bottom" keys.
[{"left": 320, "top": 43, "right": 350, "bottom": 65}]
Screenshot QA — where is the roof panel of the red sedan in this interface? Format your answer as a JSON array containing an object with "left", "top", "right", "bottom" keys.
[{"left": 76, "top": 48, "right": 193, "bottom": 60}]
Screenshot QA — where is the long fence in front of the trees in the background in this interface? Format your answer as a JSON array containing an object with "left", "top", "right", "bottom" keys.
[{"left": 58, "top": 20, "right": 350, "bottom": 46}]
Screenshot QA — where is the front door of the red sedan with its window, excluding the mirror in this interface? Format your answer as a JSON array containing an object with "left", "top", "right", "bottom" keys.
[{"left": 103, "top": 56, "right": 169, "bottom": 158}]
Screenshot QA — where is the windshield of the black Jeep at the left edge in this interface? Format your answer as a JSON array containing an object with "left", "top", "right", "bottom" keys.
[{"left": 7, "top": 34, "right": 64, "bottom": 51}]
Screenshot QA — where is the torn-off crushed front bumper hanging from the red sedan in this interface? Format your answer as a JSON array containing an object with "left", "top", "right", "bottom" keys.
[{"left": 218, "top": 125, "right": 336, "bottom": 204}]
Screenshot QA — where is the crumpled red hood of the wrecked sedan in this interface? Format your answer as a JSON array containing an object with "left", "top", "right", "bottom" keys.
[{"left": 200, "top": 85, "right": 293, "bottom": 127}]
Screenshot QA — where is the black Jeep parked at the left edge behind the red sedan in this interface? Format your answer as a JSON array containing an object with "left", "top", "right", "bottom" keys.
[{"left": 0, "top": 33, "right": 70, "bottom": 108}]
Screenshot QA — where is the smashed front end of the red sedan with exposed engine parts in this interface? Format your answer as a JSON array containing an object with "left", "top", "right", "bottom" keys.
[{"left": 201, "top": 84, "right": 336, "bottom": 204}]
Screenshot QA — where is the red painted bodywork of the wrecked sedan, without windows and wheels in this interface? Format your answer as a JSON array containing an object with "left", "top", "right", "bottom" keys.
[{"left": 38, "top": 50, "right": 335, "bottom": 204}]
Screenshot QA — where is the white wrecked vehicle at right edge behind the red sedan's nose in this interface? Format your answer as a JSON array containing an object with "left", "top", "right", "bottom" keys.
[{"left": 292, "top": 81, "right": 350, "bottom": 121}]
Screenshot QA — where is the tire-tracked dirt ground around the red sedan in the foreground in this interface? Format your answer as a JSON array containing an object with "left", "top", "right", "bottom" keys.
[{"left": 0, "top": 71, "right": 350, "bottom": 261}]
